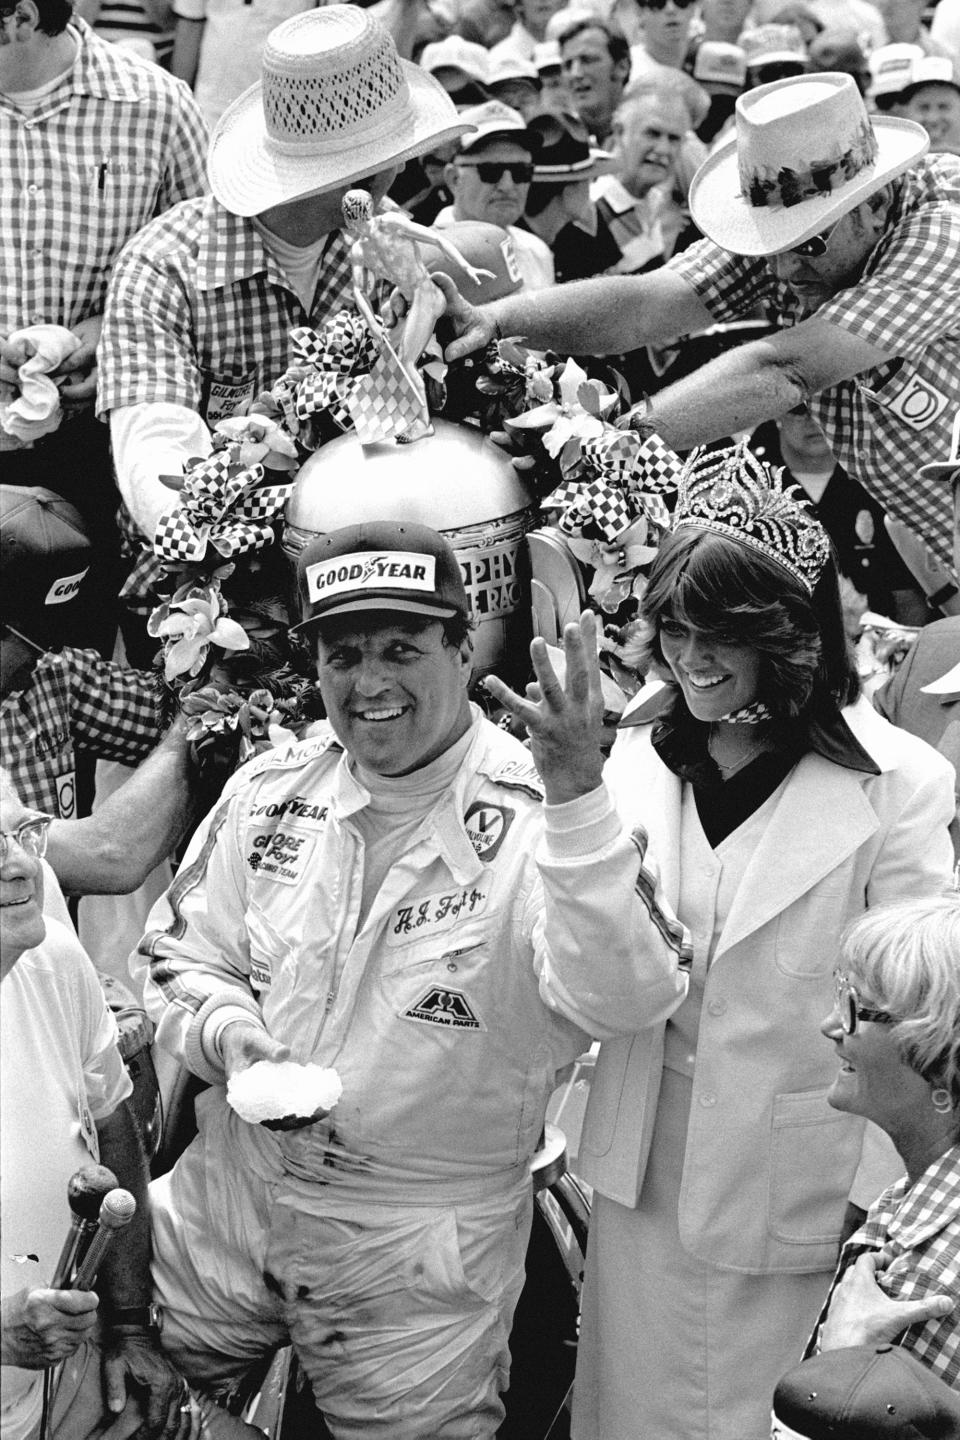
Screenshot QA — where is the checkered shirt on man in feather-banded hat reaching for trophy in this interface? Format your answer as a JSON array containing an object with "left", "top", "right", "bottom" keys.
[{"left": 668, "top": 154, "right": 960, "bottom": 563}]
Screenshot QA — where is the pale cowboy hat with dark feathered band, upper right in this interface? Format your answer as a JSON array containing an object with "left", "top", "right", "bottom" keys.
[{"left": 689, "top": 71, "right": 930, "bottom": 255}]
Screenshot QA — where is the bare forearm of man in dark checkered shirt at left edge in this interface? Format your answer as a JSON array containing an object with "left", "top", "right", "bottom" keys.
[{"left": 47, "top": 719, "right": 194, "bottom": 896}]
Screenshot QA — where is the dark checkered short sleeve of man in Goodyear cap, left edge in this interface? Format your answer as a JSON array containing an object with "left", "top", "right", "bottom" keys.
[{"left": 60, "top": 648, "right": 163, "bottom": 765}]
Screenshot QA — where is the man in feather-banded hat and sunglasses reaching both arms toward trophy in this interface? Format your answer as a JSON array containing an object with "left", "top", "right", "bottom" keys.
[{"left": 448, "top": 72, "right": 960, "bottom": 573}]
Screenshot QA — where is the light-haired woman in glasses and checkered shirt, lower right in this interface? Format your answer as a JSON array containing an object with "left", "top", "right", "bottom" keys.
[{"left": 810, "top": 893, "right": 960, "bottom": 1390}]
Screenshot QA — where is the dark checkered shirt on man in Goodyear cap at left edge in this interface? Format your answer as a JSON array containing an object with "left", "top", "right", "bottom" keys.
[{"left": 0, "top": 648, "right": 164, "bottom": 819}]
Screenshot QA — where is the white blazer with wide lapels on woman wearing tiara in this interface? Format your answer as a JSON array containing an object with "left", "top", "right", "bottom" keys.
[{"left": 579, "top": 688, "right": 954, "bottom": 1273}]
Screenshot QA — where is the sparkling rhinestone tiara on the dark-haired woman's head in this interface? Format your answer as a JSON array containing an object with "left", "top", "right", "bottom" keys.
[{"left": 674, "top": 441, "right": 830, "bottom": 595}]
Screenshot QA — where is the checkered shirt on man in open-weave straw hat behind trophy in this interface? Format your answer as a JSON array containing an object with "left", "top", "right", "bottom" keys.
[{"left": 98, "top": 196, "right": 353, "bottom": 426}]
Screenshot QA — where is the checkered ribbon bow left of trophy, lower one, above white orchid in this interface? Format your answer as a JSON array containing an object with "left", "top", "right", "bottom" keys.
[{"left": 154, "top": 442, "right": 294, "bottom": 563}]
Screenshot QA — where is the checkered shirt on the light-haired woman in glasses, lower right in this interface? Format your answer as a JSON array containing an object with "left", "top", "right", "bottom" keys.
[{"left": 807, "top": 1145, "right": 960, "bottom": 1390}]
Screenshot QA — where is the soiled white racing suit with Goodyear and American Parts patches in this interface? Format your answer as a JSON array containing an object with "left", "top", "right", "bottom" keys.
[{"left": 141, "top": 714, "right": 687, "bottom": 1440}]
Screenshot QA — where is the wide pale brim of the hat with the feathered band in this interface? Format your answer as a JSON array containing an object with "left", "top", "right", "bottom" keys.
[{"left": 689, "top": 115, "right": 930, "bottom": 255}]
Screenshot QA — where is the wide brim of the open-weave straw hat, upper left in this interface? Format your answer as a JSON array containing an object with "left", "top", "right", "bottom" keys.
[{"left": 207, "top": 60, "right": 474, "bottom": 216}]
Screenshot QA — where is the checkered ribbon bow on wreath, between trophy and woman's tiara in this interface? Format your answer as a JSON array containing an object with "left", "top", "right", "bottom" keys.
[{"left": 543, "top": 426, "right": 684, "bottom": 544}]
